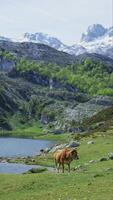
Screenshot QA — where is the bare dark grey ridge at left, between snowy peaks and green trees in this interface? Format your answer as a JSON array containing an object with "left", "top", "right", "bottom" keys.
[{"left": 0, "top": 41, "right": 75, "bottom": 70}]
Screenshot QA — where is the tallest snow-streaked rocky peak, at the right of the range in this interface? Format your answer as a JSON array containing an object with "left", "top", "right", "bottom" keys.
[{"left": 62, "top": 24, "right": 113, "bottom": 58}]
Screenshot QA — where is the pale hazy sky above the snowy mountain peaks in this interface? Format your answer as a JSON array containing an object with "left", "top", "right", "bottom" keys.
[{"left": 0, "top": 0, "right": 113, "bottom": 44}]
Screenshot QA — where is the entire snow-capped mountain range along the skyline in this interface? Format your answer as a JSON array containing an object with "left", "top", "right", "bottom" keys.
[{"left": 0, "top": 24, "right": 113, "bottom": 58}]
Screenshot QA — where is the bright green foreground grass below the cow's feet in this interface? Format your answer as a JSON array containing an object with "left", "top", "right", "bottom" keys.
[{"left": 0, "top": 161, "right": 113, "bottom": 200}]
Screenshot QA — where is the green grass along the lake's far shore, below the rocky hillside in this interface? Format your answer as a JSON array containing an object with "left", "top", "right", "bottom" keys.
[{"left": 0, "top": 114, "right": 70, "bottom": 142}]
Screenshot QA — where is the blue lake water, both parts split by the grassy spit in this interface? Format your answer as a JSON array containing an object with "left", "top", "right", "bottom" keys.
[{"left": 0, "top": 138, "right": 53, "bottom": 174}]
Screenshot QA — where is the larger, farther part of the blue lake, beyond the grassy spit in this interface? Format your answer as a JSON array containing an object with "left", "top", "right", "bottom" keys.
[{"left": 0, "top": 138, "right": 53, "bottom": 157}]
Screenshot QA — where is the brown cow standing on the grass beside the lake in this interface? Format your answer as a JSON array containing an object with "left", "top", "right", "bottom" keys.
[{"left": 54, "top": 148, "right": 79, "bottom": 173}]
